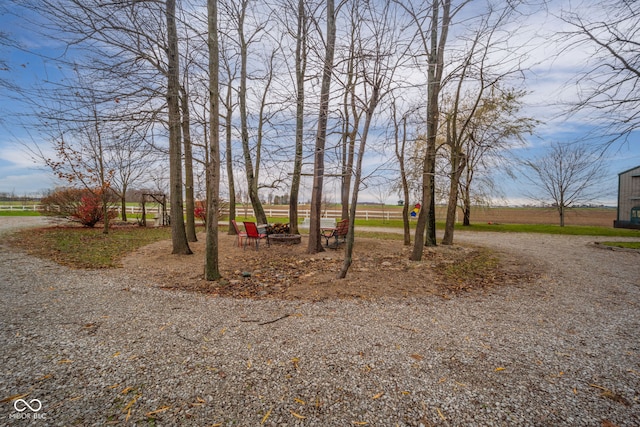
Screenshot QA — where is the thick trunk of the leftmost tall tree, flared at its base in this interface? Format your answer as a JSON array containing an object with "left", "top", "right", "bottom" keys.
[{"left": 167, "top": 0, "right": 192, "bottom": 255}]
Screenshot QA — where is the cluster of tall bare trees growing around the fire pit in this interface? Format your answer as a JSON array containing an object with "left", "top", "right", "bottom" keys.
[{"left": 3, "top": 0, "right": 635, "bottom": 280}]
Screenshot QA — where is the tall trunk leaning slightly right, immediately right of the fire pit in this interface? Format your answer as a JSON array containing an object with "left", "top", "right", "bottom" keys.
[{"left": 307, "top": 0, "right": 336, "bottom": 254}]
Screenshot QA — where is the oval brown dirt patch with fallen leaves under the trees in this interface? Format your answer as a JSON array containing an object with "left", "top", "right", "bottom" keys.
[{"left": 123, "top": 234, "right": 539, "bottom": 300}]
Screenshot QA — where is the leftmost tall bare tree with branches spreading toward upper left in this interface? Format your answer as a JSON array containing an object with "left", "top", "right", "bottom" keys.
[{"left": 21, "top": 0, "right": 191, "bottom": 254}]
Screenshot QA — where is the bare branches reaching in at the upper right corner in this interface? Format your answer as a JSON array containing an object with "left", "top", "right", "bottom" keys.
[{"left": 560, "top": 0, "right": 640, "bottom": 142}]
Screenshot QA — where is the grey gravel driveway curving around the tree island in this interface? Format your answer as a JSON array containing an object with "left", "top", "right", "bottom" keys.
[{"left": 0, "top": 217, "right": 640, "bottom": 427}]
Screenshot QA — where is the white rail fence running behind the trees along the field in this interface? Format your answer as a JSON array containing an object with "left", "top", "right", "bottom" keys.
[{"left": 0, "top": 205, "right": 402, "bottom": 220}]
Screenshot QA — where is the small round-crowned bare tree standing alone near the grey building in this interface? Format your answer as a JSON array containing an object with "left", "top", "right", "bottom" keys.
[{"left": 522, "top": 142, "right": 606, "bottom": 227}]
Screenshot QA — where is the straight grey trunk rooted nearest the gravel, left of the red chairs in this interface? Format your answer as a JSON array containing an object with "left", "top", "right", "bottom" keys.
[{"left": 204, "top": 0, "right": 222, "bottom": 281}]
